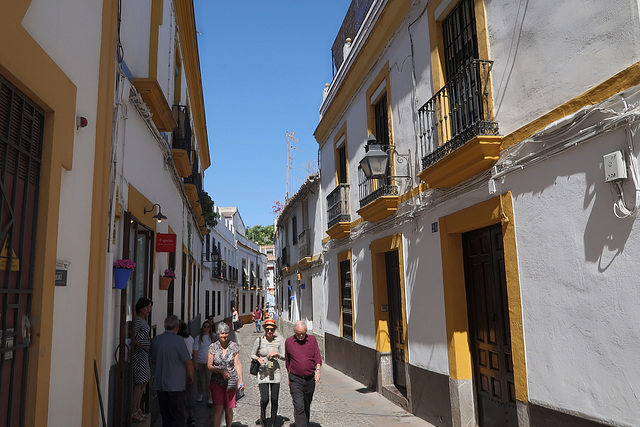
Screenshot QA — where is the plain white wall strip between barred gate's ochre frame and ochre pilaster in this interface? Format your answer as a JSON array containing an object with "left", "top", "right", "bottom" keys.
[{"left": 22, "top": 0, "right": 102, "bottom": 426}]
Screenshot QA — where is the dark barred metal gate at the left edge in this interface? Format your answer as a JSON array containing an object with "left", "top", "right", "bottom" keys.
[{"left": 0, "top": 72, "right": 44, "bottom": 427}]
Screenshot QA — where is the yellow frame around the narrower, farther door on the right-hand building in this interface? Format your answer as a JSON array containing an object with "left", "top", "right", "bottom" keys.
[{"left": 371, "top": 233, "right": 409, "bottom": 356}]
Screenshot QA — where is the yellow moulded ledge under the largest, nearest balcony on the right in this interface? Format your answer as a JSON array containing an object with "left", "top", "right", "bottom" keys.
[{"left": 418, "top": 136, "right": 503, "bottom": 188}]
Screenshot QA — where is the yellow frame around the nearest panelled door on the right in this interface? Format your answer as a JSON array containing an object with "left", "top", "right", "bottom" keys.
[{"left": 440, "top": 196, "right": 528, "bottom": 402}]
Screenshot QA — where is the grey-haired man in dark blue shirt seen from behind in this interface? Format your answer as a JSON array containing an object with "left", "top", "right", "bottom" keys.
[{"left": 149, "top": 315, "right": 194, "bottom": 427}]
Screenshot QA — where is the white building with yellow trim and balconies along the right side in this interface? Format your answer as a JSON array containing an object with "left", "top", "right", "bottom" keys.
[{"left": 315, "top": 0, "right": 640, "bottom": 426}]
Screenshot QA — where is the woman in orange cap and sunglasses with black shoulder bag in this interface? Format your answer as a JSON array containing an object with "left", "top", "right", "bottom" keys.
[{"left": 251, "top": 319, "right": 284, "bottom": 427}]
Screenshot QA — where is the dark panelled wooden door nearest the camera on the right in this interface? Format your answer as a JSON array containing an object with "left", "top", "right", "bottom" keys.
[{"left": 463, "top": 224, "right": 518, "bottom": 427}]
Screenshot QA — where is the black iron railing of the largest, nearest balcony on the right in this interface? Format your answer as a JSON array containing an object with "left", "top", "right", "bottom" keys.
[{"left": 418, "top": 59, "right": 498, "bottom": 169}]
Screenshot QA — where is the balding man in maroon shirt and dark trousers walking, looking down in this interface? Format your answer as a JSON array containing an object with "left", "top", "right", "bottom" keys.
[{"left": 284, "top": 320, "right": 322, "bottom": 427}]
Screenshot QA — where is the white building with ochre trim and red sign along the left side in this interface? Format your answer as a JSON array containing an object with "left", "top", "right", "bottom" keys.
[{"left": 0, "top": 0, "right": 210, "bottom": 427}]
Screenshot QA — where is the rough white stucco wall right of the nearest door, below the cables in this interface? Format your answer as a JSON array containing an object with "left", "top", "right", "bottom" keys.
[{"left": 507, "top": 124, "right": 640, "bottom": 424}]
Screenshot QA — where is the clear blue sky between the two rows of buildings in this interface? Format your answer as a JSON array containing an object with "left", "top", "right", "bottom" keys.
[{"left": 194, "top": 0, "right": 350, "bottom": 227}]
